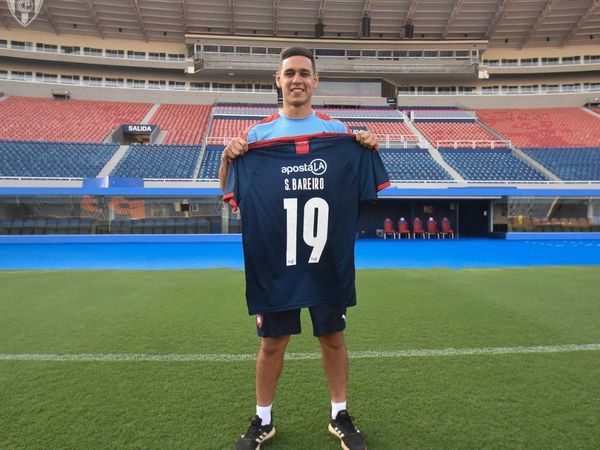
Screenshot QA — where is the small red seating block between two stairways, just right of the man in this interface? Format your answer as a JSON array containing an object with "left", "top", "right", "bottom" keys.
[{"left": 414, "top": 122, "right": 504, "bottom": 148}]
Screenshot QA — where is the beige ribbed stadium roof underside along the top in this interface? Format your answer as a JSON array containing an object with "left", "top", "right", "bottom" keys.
[{"left": 0, "top": 0, "right": 600, "bottom": 48}]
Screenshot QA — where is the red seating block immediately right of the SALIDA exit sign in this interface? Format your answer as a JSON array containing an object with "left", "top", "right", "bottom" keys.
[{"left": 150, "top": 104, "right": 211, "bottom": 145}]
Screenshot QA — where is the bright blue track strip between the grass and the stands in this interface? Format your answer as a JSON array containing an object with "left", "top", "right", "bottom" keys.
[{"left": 0, "top": 236, "right": 600, "bottom": 270}]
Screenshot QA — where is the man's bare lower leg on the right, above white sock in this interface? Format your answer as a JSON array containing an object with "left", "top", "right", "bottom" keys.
[{"left": 319, "top": 331, "right": 348, "bottom": 403}]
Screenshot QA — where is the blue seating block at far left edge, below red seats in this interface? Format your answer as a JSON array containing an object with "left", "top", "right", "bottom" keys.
[{"left": 0, "top": 141, "right": 119, "bottom": 178}]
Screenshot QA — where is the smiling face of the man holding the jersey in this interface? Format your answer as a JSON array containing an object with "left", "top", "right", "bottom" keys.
[{"left": 275, "top": 55, "right": 319, "bottom": 107}]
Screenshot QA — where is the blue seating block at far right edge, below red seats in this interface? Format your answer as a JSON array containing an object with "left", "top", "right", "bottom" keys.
[{"left": 522, "top": 147, "right": 600, "bottom": 181}]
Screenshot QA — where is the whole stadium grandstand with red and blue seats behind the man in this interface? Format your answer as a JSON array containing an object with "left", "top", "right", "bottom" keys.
[{"left": 0, "top": 0, "right": 600, "bottom": 239}]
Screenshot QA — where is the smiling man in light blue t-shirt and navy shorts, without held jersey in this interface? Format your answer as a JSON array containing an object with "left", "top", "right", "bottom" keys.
[{"left": 219, "top": 47, "right": 379, "bottom": 450}]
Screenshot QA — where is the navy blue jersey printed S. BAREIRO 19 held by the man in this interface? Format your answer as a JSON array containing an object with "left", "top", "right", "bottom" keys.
[{"left": 223, "top": 133, "right": 389, "bottom": 314}]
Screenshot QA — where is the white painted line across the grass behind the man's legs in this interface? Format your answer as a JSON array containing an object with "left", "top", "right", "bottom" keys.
[{"left": 0, "top": 344, "right": 600, "bottom": 362}]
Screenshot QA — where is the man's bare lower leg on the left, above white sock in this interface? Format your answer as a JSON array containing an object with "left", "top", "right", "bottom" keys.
[{"left": 256, "top": 336, "right": 290, "bottom": 406}]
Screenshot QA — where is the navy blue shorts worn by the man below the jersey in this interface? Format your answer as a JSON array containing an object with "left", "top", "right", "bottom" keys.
[{"left": 256, "top": 303, "right": 346, "bottom": 337}]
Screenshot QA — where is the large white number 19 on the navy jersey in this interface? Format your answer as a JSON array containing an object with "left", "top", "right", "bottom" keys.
[{"left": 283, "top": 197, "right": 329, "bottom": 266}]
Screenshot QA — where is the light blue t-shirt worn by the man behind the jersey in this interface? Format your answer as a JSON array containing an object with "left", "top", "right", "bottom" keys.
[{"left": 246, "top": 111, "right": 348, "bottom": 142}]
